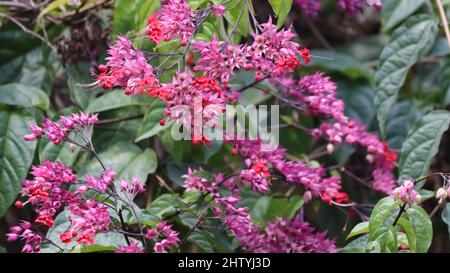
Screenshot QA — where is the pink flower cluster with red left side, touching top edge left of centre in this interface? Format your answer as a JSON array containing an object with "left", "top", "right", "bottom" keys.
[{"left": 147, "top": 0, "right": 194, "bottom": 46}]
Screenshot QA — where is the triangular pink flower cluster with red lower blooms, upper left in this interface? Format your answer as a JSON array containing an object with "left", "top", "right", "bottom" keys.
[{"left": 97, "top": 36, "right": 163, "bottom": 97}]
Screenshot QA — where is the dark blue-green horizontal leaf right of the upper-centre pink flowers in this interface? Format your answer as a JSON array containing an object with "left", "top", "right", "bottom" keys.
[{"left": 309, "top": 50, "right": 373, "bottom": 80}]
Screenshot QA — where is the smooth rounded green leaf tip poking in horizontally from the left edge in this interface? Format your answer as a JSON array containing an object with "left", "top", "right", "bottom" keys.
[{"left": 0, "top": 83, "right": 50, "bottom": 110}]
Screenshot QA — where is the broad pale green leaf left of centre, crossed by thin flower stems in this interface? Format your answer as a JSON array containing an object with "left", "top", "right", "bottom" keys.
[{"left": 80, "top": 142, "right": 158, "bottom": 183}]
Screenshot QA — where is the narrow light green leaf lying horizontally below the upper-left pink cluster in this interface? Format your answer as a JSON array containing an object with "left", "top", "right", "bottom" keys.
[{"left": 86, "top": 89, "right": 152, "bottom": 113}]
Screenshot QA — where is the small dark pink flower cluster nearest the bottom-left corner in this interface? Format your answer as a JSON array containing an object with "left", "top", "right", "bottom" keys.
[{"left": 6, "top": 221, "right": 42, "bottom": 253}]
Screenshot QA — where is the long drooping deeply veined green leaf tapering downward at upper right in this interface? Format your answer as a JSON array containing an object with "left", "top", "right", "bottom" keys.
[{"left": 375, "top": 15, "right": 437, "bottom": 135}]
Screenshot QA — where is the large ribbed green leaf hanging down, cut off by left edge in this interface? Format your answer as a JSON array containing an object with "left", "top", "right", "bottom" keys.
[{"left": 0, "top": 106, "right": 36, "bottom": 216}]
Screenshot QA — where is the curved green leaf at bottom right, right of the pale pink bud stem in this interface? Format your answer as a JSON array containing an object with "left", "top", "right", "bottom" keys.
[{"left": 407, "top": 205, "right": 433, "bottom": 253}]
